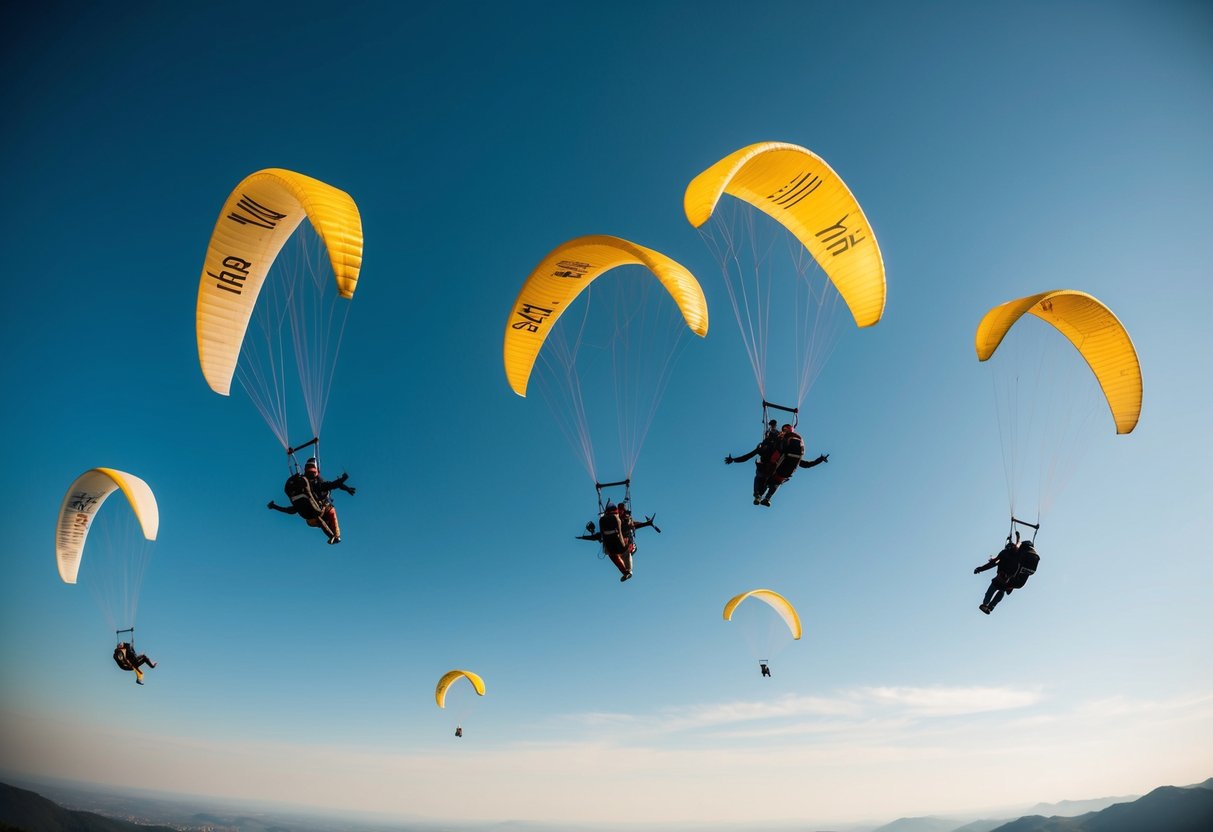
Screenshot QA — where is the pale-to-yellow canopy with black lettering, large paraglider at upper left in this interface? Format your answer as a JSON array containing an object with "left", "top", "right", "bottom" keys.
[{"left": 197, "top": 167, "right": 363, "bottom": 395}]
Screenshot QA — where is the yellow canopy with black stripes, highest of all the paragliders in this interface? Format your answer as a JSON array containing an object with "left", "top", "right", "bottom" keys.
[{"left": 683, "top": 142, "right": 885, "bottom": 326}]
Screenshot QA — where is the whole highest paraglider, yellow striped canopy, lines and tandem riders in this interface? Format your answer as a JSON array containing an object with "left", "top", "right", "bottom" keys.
[{"left": 683, "top": 142, "right": 885, "bottom": 505}]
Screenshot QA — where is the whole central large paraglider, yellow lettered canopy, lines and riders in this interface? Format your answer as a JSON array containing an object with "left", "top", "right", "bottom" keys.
[{"left": 503, "top": 235, "right": 707, "bottom": 572}]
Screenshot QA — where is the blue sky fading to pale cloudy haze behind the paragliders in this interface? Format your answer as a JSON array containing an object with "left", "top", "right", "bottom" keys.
[{"left": 0, "top": 2, "right": 1213, "bottom": 822}]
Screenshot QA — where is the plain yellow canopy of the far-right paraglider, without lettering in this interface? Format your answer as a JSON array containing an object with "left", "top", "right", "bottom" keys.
[{"left": 975, "top": 289, "right": 1141, "bottom": 433}]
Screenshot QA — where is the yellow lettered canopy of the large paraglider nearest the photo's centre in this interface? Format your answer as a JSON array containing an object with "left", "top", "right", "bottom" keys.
[{"left": 503, "top": 235, "right": 707, "bottom": 397}]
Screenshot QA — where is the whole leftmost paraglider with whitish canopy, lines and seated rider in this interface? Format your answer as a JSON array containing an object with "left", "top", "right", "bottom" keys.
[{"left": 55, "top": 468, "right": 160, "bottom": 684}]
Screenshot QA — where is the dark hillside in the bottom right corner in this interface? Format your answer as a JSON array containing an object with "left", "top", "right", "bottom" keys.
[{"left": 996, "top": 780, "right": 1213, "bottom": 832}]
